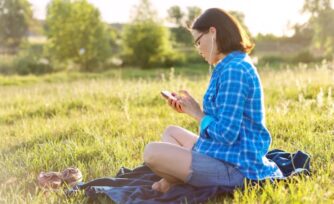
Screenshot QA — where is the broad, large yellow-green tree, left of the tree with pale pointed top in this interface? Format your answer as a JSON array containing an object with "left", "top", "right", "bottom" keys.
[{"left": 46, "top": 0, "right": 110, "bottom": 71}]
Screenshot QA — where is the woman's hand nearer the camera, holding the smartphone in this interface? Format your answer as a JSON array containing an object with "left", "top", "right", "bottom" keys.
[{"left": 176, "top": 90, "right": 204, "bottom": 122}]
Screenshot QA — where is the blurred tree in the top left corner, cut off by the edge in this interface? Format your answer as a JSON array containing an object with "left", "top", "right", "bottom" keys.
[{"left": 0, "top": 0, "right": 32, "bottom": 52}]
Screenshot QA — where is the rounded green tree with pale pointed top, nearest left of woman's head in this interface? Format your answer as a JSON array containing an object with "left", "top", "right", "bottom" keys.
[{"left": 122, "top": 0, "right": 173, "bottom": 68}]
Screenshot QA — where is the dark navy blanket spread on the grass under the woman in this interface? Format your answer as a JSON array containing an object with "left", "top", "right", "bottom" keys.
[{"left": 67, "top": 149, "right": 310, "bottom": 204}]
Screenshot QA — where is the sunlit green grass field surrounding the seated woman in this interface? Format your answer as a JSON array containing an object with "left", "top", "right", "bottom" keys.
[{"left": 0, "top": 63, "right": 334, "bottom": 203}]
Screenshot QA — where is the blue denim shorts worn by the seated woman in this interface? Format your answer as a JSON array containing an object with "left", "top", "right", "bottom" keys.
[{"left": 186, "top": 151, "right": 245, "bottom": 187}]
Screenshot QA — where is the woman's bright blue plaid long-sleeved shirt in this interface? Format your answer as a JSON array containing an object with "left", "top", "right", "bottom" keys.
[{"left": 193, "top": 51, "right": 282, "bottom": 180}]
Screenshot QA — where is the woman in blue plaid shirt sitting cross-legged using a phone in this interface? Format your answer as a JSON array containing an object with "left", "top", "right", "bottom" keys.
[{"left": 144, "top": 8, "right": 282, "bottom": 192}]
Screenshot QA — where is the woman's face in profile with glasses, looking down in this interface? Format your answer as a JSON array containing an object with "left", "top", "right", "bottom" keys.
[{"left": 191, "top": 28, "right": 219, "bottom": 64}]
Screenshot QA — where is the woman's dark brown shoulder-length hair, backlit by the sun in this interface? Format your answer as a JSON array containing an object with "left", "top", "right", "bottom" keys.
[{"left": 191, "top": 8, "right": 254, "bottom": 54}]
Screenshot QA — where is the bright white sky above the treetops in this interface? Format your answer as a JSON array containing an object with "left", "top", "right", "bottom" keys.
[{"left": 28, "top": 0, "right": 308, "bottom": 36}]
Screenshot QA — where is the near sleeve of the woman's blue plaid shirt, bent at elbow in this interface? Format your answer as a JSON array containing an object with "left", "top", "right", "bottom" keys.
[{"left": 202, "top": 64, "right": 249, "bottom": 145}]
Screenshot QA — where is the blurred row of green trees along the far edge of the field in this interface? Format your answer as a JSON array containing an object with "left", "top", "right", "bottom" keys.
[{"left": 0, "top": 0, "right": 334, "bottom": 74}]
